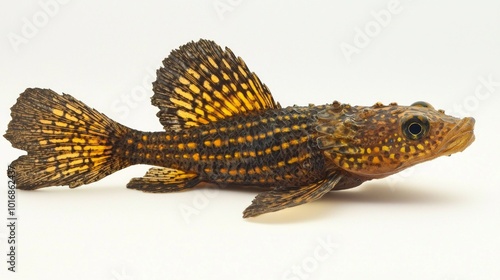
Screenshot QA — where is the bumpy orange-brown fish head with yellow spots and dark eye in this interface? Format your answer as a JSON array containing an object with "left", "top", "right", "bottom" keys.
[{"left": 317, "top": 101, "right": 475, "bottom": 179}]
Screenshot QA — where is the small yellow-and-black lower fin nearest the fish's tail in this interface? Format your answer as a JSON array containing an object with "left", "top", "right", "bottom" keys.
[{"left": 127, "top": 167, "right": 200, "bottom": 193}]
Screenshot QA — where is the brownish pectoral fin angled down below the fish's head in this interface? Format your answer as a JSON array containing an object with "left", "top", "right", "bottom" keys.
[{"left": 243, "top": 174, "right": 342, "bottom": 218}]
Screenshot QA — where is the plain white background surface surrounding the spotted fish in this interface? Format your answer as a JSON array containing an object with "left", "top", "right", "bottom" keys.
[{"left": 0, "top": 0, "right": 500, "bottom": 280}]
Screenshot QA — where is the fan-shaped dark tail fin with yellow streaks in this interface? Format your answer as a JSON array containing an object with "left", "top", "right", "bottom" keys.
[{"left": 4, "top": 88, "right": 131, "bottom": 190}]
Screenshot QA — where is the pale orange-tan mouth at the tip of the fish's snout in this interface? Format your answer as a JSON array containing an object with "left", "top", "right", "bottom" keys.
[{"left": 436, "top": 117, "right": 476, "bottom": 156}]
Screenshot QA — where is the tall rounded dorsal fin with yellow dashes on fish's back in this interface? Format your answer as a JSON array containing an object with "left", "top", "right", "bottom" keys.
[{"left": 152, "top": 40, "right": 280, "bottom": 130}]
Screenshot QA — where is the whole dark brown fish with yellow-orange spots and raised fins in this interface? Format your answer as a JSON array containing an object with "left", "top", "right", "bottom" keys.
[{"left": 4, "top": 39, "right": 475, "bottom": 218}]
